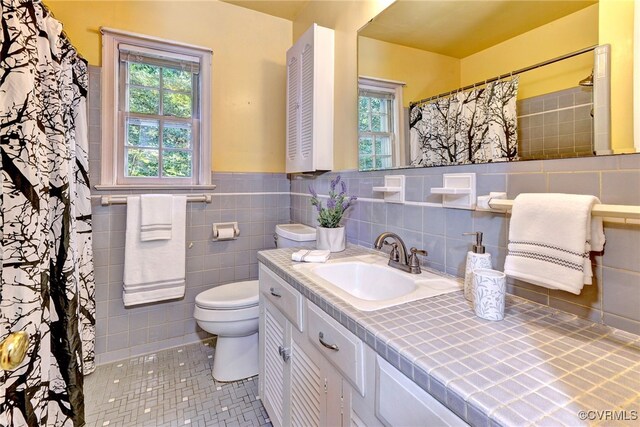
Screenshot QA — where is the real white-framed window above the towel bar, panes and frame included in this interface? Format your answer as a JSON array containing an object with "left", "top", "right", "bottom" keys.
[{"left": 101, "top": 28, "right": 211, "bottom": 187}]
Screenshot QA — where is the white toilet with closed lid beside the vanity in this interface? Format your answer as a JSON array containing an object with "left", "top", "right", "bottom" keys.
[{"left": 193, "top": 224, "right": 316, "bottom": 382}]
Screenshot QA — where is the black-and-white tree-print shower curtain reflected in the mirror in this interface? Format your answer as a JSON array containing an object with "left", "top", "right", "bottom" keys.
[{"left": 410, "top": 77, "right": 518, "bottom": 167}]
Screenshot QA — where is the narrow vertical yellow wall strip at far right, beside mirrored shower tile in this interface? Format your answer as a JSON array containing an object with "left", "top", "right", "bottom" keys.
[{"left": 600, "top": 0, "right": 635, "bottom": 153}]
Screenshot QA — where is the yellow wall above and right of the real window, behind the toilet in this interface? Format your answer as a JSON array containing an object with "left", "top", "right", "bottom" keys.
[{"left": 45, "top": 0, "right": 292, "bottom": 172}]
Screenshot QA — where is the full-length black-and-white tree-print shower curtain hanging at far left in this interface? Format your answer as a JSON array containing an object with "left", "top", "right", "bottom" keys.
[{"left": 0, "top": 0, "right": 95, "bottom": 426}]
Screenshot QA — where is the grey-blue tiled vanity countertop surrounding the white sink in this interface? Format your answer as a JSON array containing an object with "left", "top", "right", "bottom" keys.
[{"left": 258, "top": 246, "right": 640, "bottom": 426}]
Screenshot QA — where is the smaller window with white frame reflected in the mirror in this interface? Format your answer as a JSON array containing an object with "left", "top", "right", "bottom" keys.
[{"left": 358, "top": 77, "right": 404, "bottom": 170}]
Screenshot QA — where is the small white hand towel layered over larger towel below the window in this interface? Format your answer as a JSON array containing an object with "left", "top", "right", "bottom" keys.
[{"left": 140, "top": 194, "right": 173, "bottom": 242}]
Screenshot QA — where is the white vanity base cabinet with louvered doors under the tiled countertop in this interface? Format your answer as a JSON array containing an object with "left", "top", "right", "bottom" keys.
[{"left": 259, "top": 264, "right": 466, "bottom": 427}]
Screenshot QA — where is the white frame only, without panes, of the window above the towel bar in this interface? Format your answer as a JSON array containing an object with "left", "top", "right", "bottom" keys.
[{"left": 96, "top": 27, "right": 213, "bottom": 189}]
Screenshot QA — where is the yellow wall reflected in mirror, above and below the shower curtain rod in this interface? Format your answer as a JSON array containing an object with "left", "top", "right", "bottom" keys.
[{"left": 460, "top": 4, "right": 598, "bottom": 99}]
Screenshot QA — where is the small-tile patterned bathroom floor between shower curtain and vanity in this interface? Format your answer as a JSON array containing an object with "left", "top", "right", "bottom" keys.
[{"left": 85, "top": 341, "right": 271, "bottom": 427}]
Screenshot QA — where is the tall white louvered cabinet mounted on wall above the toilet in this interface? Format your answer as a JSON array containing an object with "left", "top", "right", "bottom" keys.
[{"left": 285, "top": 24, "right": 334, "bottom": 173}]
